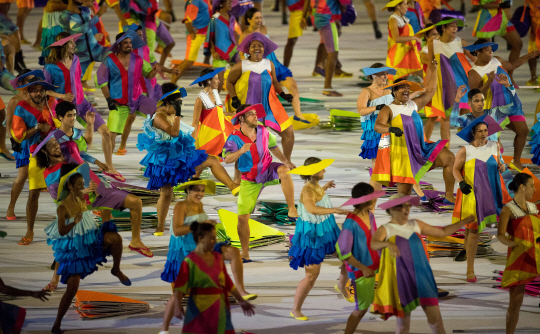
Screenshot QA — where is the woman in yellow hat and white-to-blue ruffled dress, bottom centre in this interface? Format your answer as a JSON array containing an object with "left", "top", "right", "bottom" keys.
[{"left": 288, "top": 157, "right": 350, "bottom": 321}]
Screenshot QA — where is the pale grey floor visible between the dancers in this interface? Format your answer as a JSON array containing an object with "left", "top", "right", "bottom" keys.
[{"left": 0, "top": 0, "right": 540, "bottom": 334}]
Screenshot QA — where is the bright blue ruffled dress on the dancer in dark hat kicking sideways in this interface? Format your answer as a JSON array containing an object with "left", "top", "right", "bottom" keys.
[{"left": 137, "top": 114, "right": 208, "bottom": 190}]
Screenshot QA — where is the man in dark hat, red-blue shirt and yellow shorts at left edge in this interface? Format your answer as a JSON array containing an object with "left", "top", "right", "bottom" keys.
[{"left": 11, "top": 77, "right": 60, "bottom": 246}]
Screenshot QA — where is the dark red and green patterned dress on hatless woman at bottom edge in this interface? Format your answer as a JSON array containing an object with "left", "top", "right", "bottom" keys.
[{"left": 174, "top": 252, "right": 235, "bottom": 334}]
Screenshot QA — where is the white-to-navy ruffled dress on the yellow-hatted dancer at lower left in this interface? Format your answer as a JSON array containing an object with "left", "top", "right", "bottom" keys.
[{"left": 45, "top": 210, "right": 117, "bottom": 284}]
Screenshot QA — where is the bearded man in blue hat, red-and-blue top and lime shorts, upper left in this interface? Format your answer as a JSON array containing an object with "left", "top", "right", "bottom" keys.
[{"left": 96, "top": 30, "right": 160, "bottom": 156}]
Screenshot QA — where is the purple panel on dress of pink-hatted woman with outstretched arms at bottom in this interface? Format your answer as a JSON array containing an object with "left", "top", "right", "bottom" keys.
[{"left": 396, "top": 236, "right": 418, "bottom": 307}]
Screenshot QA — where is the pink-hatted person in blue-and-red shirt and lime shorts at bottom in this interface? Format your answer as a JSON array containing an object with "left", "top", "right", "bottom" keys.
[{"left": 336, "top": 182, "right": 385, "bottom": 334}]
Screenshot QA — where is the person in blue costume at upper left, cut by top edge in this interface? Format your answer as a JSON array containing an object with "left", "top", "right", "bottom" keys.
[{"left": 60, "top": 0, "right": 108, "bottom": 79}]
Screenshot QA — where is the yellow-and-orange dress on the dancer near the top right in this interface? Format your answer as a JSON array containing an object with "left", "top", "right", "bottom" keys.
[{"left": 386, "top": 14, "right": 422, "bottom": 80}]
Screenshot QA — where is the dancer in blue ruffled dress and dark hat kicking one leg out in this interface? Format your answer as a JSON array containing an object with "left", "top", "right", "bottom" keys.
[{"left": 137, "top": 83, "right": 240, "bottom": 236}]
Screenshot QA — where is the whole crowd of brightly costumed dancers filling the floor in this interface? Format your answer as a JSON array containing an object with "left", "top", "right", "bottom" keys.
[{"left": 0, "top": 0, "right": 540, "bottom": 334}]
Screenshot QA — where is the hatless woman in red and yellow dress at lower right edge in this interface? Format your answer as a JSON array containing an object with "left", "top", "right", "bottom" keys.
[{"left": 497, "top": 173, "right": 540, "bottom": 334}]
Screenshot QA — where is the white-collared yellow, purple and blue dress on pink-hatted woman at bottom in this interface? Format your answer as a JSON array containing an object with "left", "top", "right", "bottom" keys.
[{"left": 373, "top": 219, "right": 439, "bottom": 320}]
